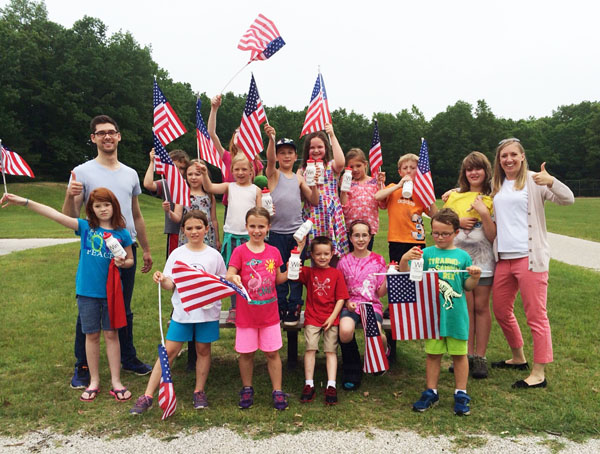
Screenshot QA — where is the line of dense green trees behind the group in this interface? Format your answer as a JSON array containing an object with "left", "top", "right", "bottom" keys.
[{"left": 0, "top": 0, "right": 600, "bottom": 195}]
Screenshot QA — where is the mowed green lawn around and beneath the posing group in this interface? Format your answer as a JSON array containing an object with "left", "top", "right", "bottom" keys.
[{"left": 0, "top": 183, "right": 600, "bottom": 440}]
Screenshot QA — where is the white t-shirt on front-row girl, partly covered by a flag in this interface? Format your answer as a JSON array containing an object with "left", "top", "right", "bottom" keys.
[{"left": 163, "top": 245, "right": 227, "bottom": 323}]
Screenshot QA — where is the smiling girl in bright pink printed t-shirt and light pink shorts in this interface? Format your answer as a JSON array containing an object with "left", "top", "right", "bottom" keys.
[{"left": 227, "top": 207, "right": 288, "bottom": 410}]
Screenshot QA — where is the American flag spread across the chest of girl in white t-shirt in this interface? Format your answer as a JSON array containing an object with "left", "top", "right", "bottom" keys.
[{"left": 173, "top": 260, "right": 250, "bottom": 312}]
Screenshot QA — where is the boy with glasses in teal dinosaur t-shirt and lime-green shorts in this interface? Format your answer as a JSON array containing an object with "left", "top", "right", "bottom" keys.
[{"left": 399, "top": 208, "right": 481, "bottom": 416}]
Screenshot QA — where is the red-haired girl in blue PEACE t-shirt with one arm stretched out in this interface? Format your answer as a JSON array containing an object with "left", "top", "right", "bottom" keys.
[{"left": 0, "top": 188, "right": 133, "bottom": 402}]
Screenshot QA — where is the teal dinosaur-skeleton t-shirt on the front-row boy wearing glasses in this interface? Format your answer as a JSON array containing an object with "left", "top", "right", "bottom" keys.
[{"left": 423, "top": 246, "right": 472, "bottom": 340}]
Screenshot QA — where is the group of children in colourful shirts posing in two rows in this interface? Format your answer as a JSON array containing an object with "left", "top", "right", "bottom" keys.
[{"left": 2, "top": 103, "right": 491, "bottom": 415}]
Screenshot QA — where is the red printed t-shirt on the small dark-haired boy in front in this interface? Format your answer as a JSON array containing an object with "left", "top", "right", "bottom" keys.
[{"left": 299, "top": 266, "right": 350, "bottom": 326}]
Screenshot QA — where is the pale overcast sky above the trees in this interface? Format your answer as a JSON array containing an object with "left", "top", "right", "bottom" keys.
[{"left": 0, "top": 0, "right": 600, "bottom": 119}]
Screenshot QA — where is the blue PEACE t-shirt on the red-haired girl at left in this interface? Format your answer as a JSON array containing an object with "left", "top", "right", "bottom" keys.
[{"left": 75, "top": 219, "right": 133, "bottom": 298}]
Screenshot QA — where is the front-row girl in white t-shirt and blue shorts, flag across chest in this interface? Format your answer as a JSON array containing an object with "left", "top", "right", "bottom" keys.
[{"left": 129, "top": 210, "right": 226, "bottom": 415}]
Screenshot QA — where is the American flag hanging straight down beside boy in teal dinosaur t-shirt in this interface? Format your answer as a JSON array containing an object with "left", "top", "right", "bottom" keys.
[{"left": 387, "top": 273, "right": 440, "bottom": 340}]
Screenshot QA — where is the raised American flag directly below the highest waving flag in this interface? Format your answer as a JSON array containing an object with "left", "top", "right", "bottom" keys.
[{"left": 235, "top": 74, "right": 267, "bottom": 162}]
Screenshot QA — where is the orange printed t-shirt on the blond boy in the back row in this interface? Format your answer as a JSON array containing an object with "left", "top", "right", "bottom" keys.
[{"left": 386, "top": 183, "right": 425, "bottom": 244}]
